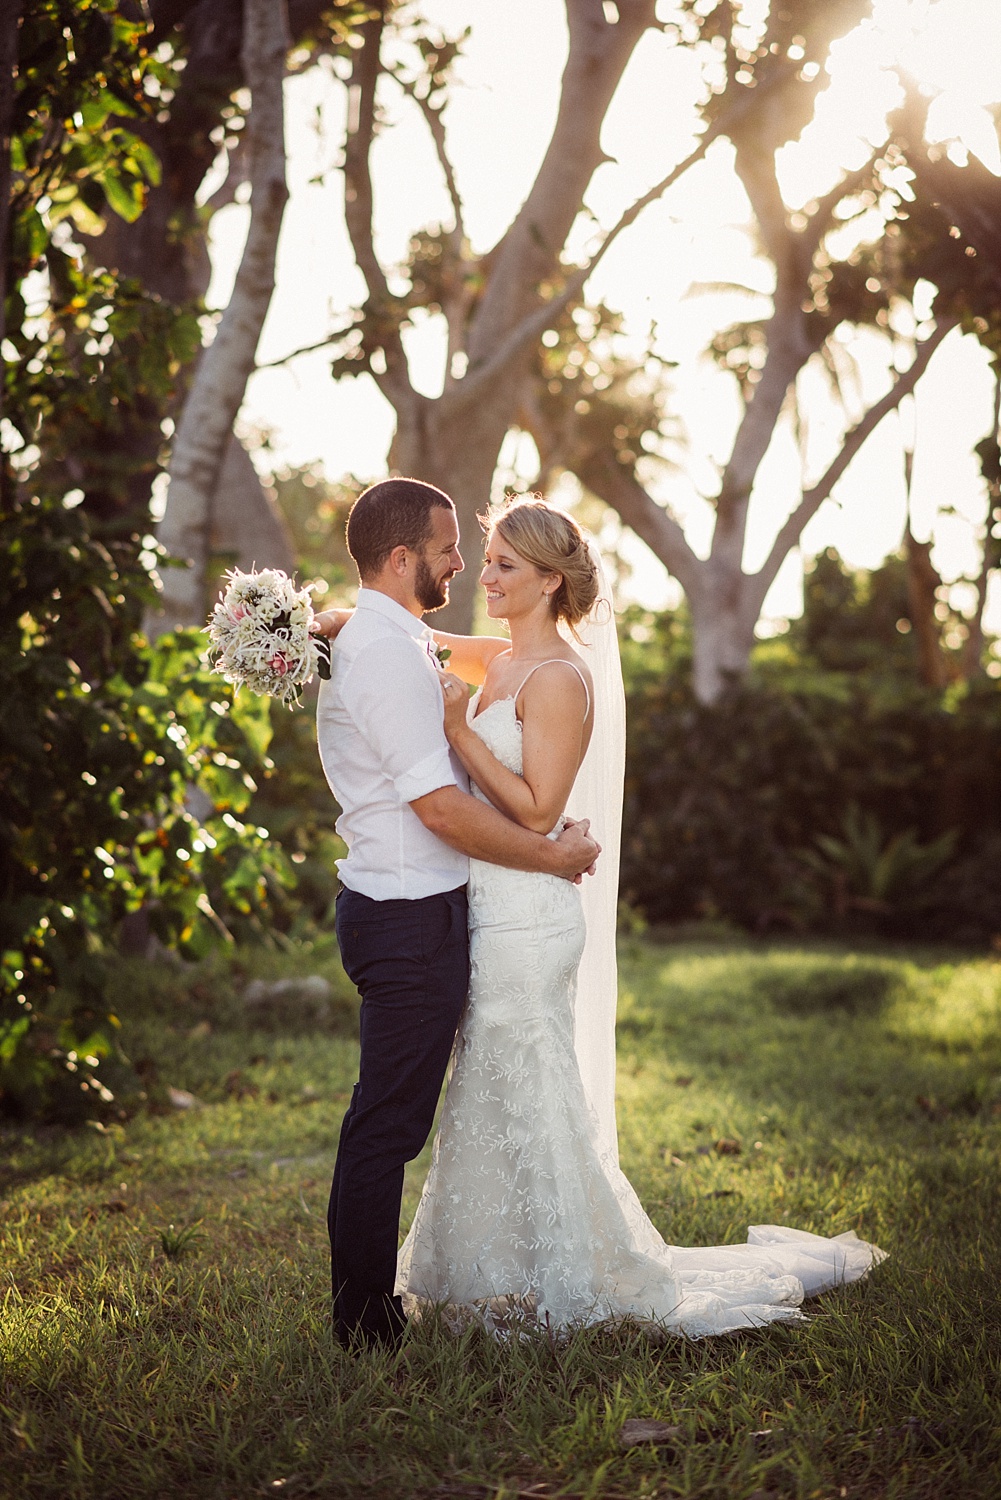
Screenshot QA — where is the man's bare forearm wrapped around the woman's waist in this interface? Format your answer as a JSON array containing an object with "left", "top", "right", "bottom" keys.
[{"left": 410, "top": 786, "right": 600, "bottom": 881}]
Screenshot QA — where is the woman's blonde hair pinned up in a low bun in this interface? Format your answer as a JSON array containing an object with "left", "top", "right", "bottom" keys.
[{"left": 479, "top": 495, "right": 599, "bottom": 629}]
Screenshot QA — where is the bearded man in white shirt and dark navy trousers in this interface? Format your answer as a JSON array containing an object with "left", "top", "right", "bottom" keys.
[{"left": 317, "top": 479, "right": 599, "bottom": 1344}]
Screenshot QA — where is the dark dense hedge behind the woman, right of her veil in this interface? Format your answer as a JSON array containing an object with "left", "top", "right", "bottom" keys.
[{"left": 623, "top": 594, "right": 1001, "bottom": 942}]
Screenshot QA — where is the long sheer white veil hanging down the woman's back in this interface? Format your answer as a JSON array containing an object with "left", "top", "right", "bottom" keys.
[{"left": 560, "top": 539, "right": 626, "bottom": 1166}]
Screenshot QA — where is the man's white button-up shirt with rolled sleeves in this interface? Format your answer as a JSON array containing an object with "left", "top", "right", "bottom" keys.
[{"left": 317, "top": 588, "right": 470, "bottom": 902}]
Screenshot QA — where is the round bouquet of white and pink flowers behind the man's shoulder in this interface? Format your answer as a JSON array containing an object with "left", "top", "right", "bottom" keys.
[{"left": 206, "top": 569, "right": 330, "bottom": 708}]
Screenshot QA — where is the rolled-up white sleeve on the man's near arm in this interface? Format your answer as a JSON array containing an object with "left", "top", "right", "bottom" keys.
[{"left": 342, "top": 636, "right": 458, "bottom": 803}]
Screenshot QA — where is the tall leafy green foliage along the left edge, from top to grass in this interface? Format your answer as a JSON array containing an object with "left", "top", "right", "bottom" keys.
[{"left": 0, "top": 0, "right": 289, "bottom": 1118}]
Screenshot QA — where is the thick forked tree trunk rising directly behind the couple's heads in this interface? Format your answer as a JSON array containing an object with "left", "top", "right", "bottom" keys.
[{"left": 345, "top": 0, "right": 656, "bottom": 629}]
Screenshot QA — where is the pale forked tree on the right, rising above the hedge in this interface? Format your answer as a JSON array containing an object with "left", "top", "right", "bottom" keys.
[{"left": 501, "top": 49, "right": 956, "bottom": 704}]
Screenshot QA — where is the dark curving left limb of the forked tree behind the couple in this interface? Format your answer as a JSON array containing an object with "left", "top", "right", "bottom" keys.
[{"left": 344, "top": 0, "right": 414, "bottom": 405}]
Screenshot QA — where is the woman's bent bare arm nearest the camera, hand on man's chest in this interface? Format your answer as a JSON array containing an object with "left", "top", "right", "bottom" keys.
[{"left": 441, "top": 662, "right": 587, "bottom": 834}]
